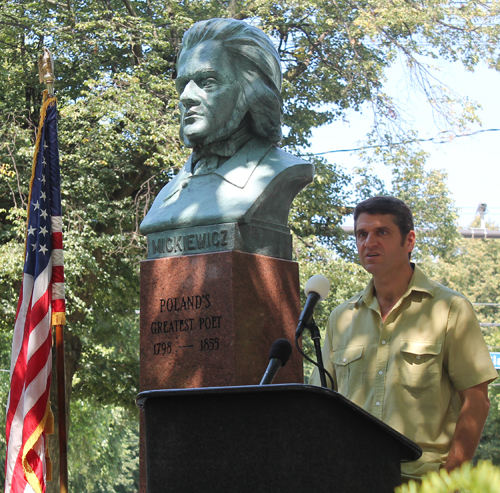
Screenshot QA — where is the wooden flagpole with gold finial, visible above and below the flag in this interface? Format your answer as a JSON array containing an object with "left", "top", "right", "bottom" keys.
[{"left": 38, "top": 47, "right": 68, "bottom": 493}]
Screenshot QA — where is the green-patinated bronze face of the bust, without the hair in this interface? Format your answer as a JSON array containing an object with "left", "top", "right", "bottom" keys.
[{"left": 176, "top": 41, "right": 247, "bottom": 147}]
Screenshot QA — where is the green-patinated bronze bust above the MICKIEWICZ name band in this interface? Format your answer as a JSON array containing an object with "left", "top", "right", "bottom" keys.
[{"left": 141, "top": 19, "right": 314, "bottom": 244}]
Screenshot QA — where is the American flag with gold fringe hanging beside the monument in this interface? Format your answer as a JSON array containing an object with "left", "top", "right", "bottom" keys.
[{"left": 5, "top": 92, "right": 65, "bottom": 493}]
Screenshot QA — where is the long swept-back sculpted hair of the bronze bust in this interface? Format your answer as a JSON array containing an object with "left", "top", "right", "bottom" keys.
[{"left": 178, "top": 19, "right": 283, "bottom": 143}]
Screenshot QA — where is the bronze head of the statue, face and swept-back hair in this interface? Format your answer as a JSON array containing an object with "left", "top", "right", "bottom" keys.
[{"left": 176, "top": 19, "right": 283, "bottom": 147}]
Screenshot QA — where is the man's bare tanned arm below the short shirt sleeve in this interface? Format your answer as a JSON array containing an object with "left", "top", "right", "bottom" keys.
[{"left": 444, "top": 382, "right": 490, "bottom": 472}]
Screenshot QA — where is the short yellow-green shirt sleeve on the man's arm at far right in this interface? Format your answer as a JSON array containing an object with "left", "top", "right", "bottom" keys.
[{"left": 444, "top": 297, "right": 498, "bottom": 391}]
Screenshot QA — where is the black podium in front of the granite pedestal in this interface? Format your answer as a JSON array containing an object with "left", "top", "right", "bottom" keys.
[{"left": 137, "top": 384, "right": 422, "bottom": 493}]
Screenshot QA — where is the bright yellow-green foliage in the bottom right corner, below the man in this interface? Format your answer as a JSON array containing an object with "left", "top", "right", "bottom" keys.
[{"left": 395, "top": 462, "right": 500, "bottom": 493}]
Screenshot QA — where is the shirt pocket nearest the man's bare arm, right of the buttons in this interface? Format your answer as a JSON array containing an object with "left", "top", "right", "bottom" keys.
[{"left": 399, "top": 341, "right": 442, "bottom": 391}]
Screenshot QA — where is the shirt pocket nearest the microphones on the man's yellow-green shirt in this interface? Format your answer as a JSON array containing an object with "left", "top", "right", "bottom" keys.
[{"left": 332, "top": 346, "right": 363, "bottom": 397}]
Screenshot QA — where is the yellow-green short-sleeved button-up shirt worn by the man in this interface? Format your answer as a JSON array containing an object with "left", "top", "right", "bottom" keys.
[{"left": 310, "top": 267, "right": 498, "bottom": 479}]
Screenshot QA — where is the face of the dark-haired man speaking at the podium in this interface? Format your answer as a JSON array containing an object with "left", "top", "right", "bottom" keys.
[{"left": 356, "top": 212, "right": 415, "bottom": 275}]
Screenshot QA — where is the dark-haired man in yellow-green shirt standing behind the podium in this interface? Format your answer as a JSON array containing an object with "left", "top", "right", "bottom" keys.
[{"left": 311, "top": 197, "right": 497, "bottom": 481}]
